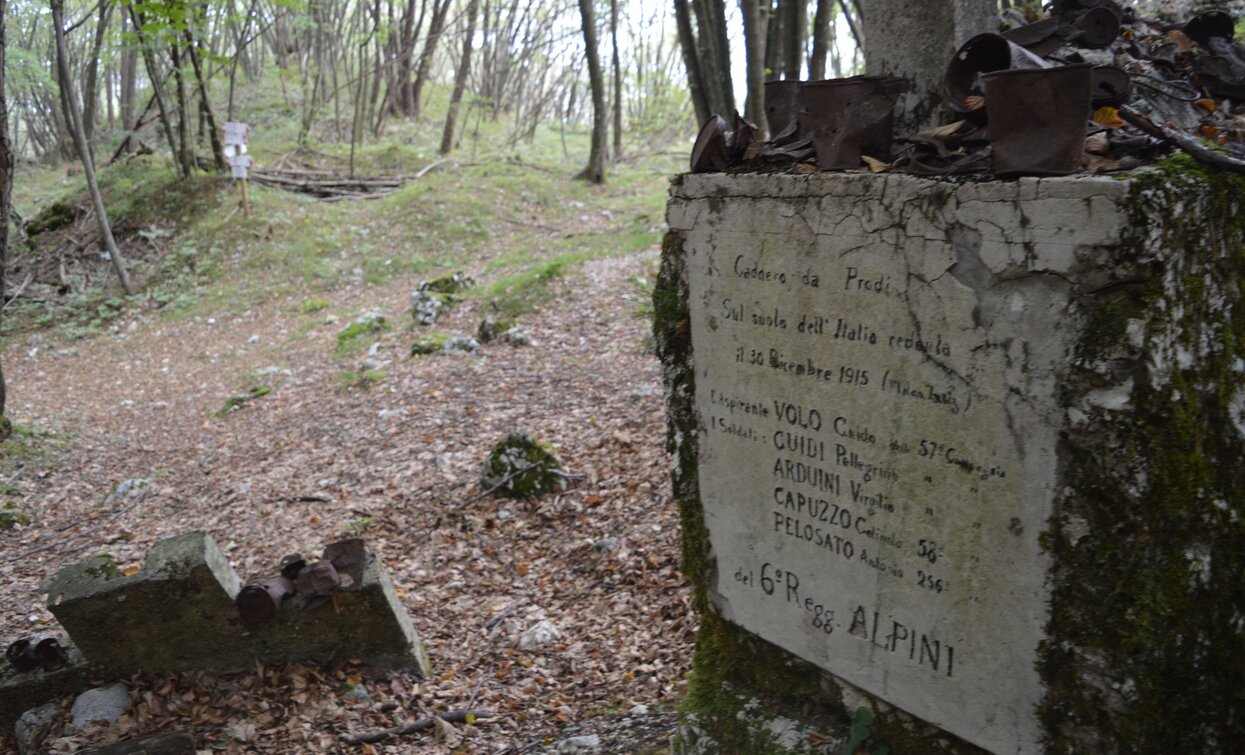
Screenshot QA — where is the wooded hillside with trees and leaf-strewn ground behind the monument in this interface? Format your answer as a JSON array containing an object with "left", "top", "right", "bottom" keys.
[{"left": 0, "top": 0, "right": 1239, "bottom": 753}]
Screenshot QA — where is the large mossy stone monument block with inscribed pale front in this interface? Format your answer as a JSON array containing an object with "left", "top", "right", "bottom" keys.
[{"left": 655, "top": 168, "right": 1245, "bottom": 754}]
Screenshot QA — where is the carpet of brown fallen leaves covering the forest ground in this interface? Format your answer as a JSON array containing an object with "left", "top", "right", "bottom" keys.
[{"left": 0, "top": 156, "right": 696, "bottom": 753}]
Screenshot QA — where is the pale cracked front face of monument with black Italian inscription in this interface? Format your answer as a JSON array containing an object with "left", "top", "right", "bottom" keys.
[{"left": 671, "top": 176, "right": 1135, "bottom": 753}]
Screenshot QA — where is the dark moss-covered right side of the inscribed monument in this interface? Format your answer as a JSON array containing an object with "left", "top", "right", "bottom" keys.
[{"left": 1041, "top": 158, "right": 1245, "bottom": 753}]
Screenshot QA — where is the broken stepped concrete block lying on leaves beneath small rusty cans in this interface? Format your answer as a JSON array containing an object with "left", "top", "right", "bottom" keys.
[{"left": 47, "top": 532, "right": 430, "bottom": 675}]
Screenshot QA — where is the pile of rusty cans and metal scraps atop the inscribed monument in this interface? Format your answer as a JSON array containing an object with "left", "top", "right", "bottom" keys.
[{"left": 691, "top": 0, "right": 1245, "bottom": 176}]
